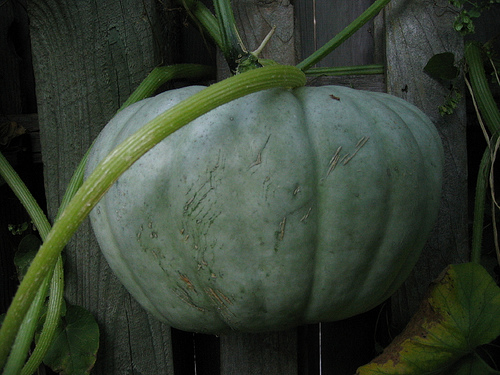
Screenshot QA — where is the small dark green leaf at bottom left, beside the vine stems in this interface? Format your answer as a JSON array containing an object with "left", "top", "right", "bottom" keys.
[{"left": 44, "top": 304, "right": 99, "bottom": 375}]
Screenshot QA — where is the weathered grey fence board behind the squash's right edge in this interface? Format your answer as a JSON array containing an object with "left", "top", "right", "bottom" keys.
[{"left": 385, "top": 0, "right": 468, "bottom": 330}]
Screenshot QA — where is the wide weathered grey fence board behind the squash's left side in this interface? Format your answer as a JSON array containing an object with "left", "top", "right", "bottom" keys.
[{"left": 28, "top": 0, "right": 176, "bottom": 374}]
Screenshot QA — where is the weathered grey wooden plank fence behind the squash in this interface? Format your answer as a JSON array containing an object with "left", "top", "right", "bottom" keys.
[{"left": 0, "top": 0, "right": 474, "bottom": 375}]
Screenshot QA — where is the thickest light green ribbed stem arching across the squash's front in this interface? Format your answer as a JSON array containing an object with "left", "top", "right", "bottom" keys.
[{"left": 0, "top": 65, "right": 306, "bottom": 367}]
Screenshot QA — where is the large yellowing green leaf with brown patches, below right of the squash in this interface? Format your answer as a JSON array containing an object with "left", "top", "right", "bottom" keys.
[{"left": 356, "top": 263, "right": 500, "bottom": 375}]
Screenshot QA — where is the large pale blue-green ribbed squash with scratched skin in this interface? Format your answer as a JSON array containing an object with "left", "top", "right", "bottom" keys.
[{"left": 86, "top": 86, "right": 443, "bottom": 333}]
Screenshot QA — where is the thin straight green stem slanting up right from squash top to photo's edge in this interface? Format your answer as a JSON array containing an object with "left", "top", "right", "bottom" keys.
[{"left": 297, "top": 0, "right": 391, "bottom": 71}]
